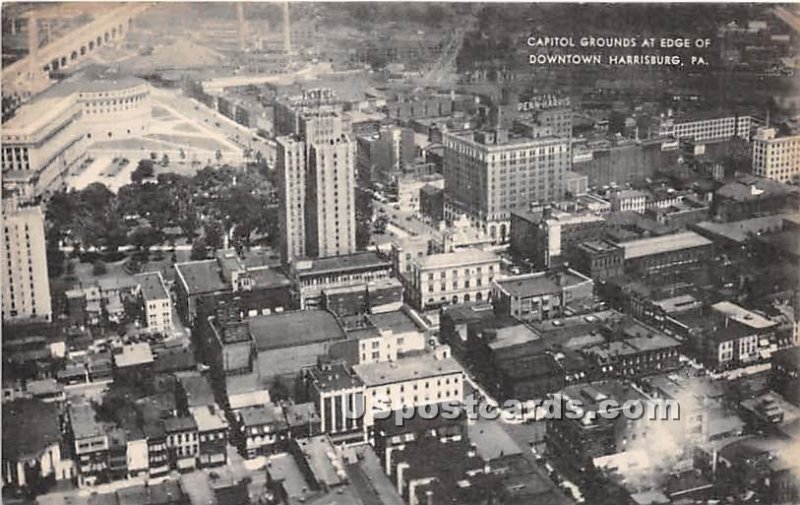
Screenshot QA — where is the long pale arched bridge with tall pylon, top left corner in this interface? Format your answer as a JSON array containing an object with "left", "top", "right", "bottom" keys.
[{"left": 2, "top": 3, "right": 150, "bottom": 100}]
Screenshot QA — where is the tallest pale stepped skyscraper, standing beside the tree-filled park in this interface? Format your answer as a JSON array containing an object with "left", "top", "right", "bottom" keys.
[{"left": 275, "top": 89, "right": 356, "bottom": 264}]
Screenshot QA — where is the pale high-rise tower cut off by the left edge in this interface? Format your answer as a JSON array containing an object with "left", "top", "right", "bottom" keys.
[{"left": 0, "top": 198, "right": 52, "bottom": 321}]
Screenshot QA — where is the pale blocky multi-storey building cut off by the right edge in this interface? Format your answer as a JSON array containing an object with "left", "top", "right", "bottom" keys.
[{"left": 753, "top": 128, "right": 800, "bottom": 182}]
